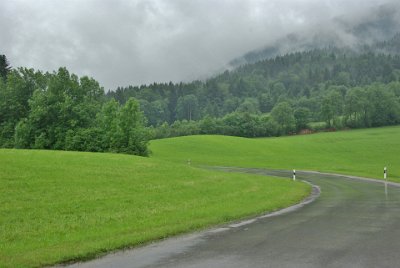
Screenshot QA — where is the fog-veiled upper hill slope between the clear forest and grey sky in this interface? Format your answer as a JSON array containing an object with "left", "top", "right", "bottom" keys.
[{"left": 229, "top": 2, "right": 400, "bottom": 68}]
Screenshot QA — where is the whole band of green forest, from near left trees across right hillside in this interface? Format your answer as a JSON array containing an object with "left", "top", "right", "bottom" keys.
[{"left": 0, "top": 35, "right": 400, "bottom": 155}]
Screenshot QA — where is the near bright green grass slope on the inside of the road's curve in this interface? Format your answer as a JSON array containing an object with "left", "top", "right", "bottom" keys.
[{"left": 0, "top": 150, "right": 310, "bottom": 267}]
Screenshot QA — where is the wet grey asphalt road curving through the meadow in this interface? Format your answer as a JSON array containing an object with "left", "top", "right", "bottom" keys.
[{"left": 67, "top": 169, "right": 400, "bottom": 268}]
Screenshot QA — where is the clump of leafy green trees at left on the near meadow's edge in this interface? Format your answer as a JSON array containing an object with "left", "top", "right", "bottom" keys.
[{"left": 0, "top": 61, "right": 150, "bottom": 155}]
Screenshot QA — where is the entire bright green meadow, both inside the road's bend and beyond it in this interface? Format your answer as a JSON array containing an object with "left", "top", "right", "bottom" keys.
[{"left": 0, "top": 127, "right": 400, "bottom": 267}]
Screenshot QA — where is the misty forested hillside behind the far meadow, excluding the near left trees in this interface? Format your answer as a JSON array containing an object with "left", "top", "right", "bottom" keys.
[{"left": 107, "top": 35, "right": 400, "bottom": 137}]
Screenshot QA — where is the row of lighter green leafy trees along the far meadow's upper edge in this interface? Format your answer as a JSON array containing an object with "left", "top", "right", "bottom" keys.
[{"left": 151, "top": 82, "right": 400, "bottom": 138}]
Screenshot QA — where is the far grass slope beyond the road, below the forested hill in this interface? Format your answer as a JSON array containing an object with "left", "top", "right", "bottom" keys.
[{"left": 151, "top": 126, "right": 400, "bottom": 181}]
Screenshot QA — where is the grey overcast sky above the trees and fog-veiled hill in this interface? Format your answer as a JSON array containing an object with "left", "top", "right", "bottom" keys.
[{"left": 0, "top": 0, "right": 395, "bottom": 90}]
